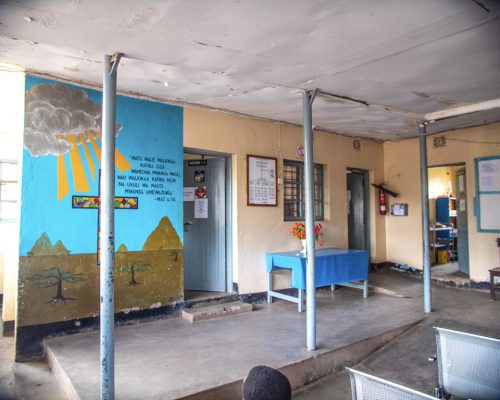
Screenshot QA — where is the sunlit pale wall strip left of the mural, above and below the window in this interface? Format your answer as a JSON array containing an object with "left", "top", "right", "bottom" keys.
[{"left": 0, "top": 69, "right": 24, "bottom": 321}]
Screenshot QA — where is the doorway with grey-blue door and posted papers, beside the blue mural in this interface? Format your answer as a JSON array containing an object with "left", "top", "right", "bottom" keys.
[{"left": 183, "top": 149, "right": 233, "bottom": 300}]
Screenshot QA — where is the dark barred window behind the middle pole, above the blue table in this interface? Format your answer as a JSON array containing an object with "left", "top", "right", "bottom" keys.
[{"left": 283, "top": 160, "right": 324, "bottom": 221}]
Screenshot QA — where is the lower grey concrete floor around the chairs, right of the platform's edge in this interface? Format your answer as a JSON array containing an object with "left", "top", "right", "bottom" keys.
[{"left": 293, "top": 271, "right": 500, "bottom": 400}]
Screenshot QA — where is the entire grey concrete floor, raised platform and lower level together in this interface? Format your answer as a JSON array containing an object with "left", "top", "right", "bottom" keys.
[{"left": 0, "top": 270, "right": 500, "bottom": 400}]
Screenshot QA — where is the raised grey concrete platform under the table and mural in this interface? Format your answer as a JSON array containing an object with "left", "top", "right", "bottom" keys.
[{"left": 47, "top": 282, "right": 424, "bottom": 400}]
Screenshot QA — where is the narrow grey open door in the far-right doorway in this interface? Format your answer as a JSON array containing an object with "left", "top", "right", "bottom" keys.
[{"left": 456, "top": 169, "right": 469, "bottom": 275}]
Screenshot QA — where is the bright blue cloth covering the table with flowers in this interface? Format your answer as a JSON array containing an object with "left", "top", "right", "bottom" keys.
[{"left": 266, "top": 249, "right": 368, "bottom": 289}]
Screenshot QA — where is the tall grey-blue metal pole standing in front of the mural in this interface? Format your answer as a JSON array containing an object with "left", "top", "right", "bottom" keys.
[{"left": 99, "top": 53, "right": 121, "bottom": 400}]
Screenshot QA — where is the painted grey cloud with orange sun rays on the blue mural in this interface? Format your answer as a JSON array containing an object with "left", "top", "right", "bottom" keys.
[{"left": 24, "top": 83, "right": 132, "bottom": 201}]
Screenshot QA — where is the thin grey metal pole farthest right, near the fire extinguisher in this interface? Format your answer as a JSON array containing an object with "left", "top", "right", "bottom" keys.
[{"left": 418, "top": 125, "right": 432, "bottom": 313}]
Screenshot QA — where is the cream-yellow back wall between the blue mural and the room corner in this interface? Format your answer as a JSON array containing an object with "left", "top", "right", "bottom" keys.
[{"left": 184, "top": 108, "right": 386, "bottom": 293}]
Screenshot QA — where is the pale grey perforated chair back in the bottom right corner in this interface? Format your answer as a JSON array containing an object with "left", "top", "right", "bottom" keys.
[{"left": 435, "top": 328, "right": 500, "bottom": 400}]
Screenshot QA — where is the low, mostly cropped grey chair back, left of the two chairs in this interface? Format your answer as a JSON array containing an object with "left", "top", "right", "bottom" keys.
[{"left": 346, "top": 368, "right": 436, "bottom": 400}]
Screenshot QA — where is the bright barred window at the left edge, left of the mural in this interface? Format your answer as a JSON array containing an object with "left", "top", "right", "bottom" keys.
[{"left": 0, "top": 160, "right": 18, "bottom": 221}]
